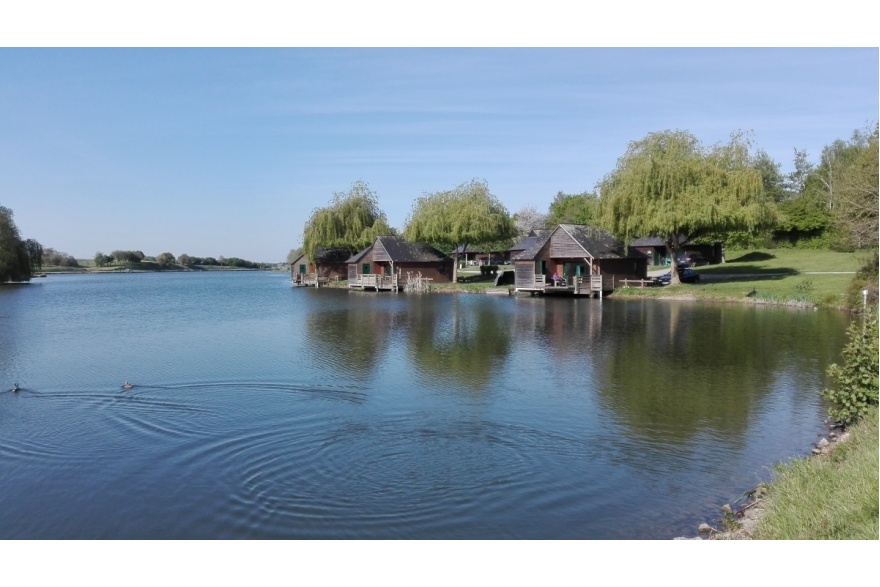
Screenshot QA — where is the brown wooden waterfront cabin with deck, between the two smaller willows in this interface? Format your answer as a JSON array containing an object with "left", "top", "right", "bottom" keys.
[{"left": 346, "top": 236, "right": 453, "bottom": 291}]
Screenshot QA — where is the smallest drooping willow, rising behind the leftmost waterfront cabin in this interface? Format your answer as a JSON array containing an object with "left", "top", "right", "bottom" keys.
[{"left": 303, "top": 181, "right": 395, "bottom": 261}]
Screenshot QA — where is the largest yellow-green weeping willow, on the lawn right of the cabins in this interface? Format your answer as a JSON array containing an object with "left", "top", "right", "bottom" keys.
[{"left": 599, "top": 130, "right": 775, "bottom": 284}]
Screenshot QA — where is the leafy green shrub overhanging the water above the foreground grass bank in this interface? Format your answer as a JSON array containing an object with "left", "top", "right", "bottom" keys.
[{"left": 819, "top": 312, "right": 880, "bottom": 424}]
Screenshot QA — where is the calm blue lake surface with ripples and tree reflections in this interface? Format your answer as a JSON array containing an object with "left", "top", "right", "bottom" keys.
[{"left": 0, "top": 272, "right": 849, "bottom": 539}]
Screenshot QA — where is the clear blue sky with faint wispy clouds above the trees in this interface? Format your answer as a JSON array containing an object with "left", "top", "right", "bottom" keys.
[{"left": 0, "top": 48, "right": 878, "bottom": 261}]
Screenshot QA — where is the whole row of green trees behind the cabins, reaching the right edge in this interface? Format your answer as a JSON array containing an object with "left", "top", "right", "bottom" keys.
[{"left": 300, "top": 125, "right": 878, "bottom": 283}]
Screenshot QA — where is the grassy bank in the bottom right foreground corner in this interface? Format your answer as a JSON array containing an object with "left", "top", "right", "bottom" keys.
[{"left": 753, "top": 408, "right": 880, "bottom": 540}]
